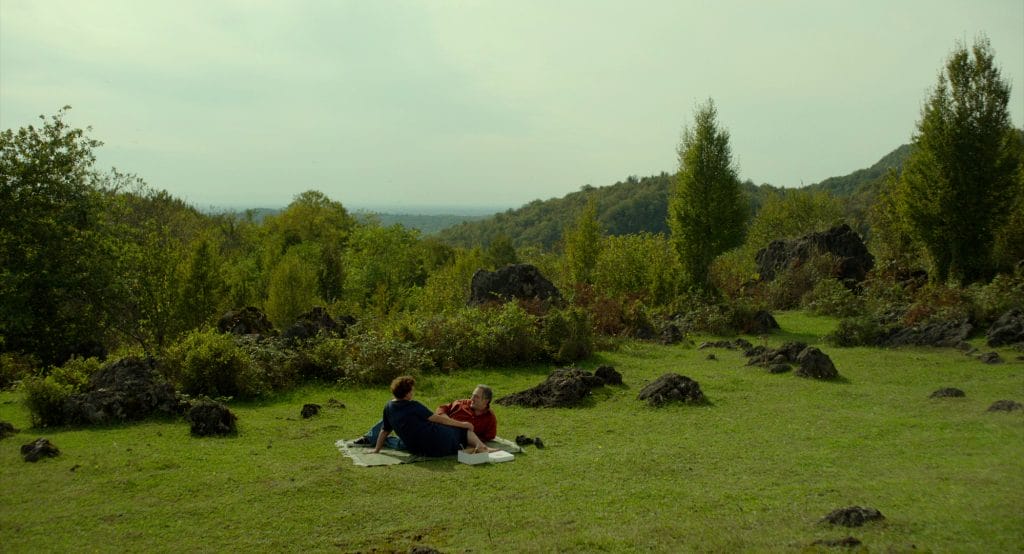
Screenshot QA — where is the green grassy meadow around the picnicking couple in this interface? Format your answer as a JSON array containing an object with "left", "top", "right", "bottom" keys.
[{"left": 0, "top": 313, "right": 1024, "bottom": 552}]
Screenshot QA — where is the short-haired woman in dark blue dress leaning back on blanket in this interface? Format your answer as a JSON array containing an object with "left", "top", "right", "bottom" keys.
[{"left": 374, "top": 375, "right": 497, "bottom": 456}]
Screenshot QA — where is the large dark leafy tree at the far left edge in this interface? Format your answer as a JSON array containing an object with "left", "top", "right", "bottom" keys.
[{"left": 0, "top": 106, "right": 111, "bottom": 365}]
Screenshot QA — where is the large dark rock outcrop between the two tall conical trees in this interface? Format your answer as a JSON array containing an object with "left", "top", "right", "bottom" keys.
[{"left": 754, "top": 224, "right": 874, "bottom": 283}]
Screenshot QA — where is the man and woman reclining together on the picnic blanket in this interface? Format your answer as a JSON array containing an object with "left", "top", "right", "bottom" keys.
[{"left": 355, "top": 375, "right": 498, "bottom": 457}]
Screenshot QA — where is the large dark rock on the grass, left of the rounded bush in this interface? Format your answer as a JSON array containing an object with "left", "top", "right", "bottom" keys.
[{"left": 63, "top": 357, "right": 181, "bottom": 425}]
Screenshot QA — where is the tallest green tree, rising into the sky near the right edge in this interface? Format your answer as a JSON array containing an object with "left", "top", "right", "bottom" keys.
[{"left": 895, "top": 37, "right": 1022, "bottom": 283}]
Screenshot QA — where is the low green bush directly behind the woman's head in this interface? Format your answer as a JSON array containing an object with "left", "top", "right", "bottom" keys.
[{"left": 341, "top": 330, "right": 431, "bottom": 385}]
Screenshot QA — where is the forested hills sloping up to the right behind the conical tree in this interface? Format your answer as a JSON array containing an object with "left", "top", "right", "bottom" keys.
[{"left": 436, "top": 144, "right": 910, "bottom": 248}]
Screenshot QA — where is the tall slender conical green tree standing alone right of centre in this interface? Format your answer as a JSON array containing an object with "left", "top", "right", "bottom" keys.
[{"left": 669, "top": 99, "right": 746, "bottom": 292}]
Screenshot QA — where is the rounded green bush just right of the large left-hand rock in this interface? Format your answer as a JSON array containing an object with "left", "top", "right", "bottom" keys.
[{"left": 167, "top": 330, "right": 270, "bottom": 397}]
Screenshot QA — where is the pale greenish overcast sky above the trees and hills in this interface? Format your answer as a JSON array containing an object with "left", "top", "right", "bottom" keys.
[{"left": 0, "top": 0, "right": 1024, "bottom": 209}]
